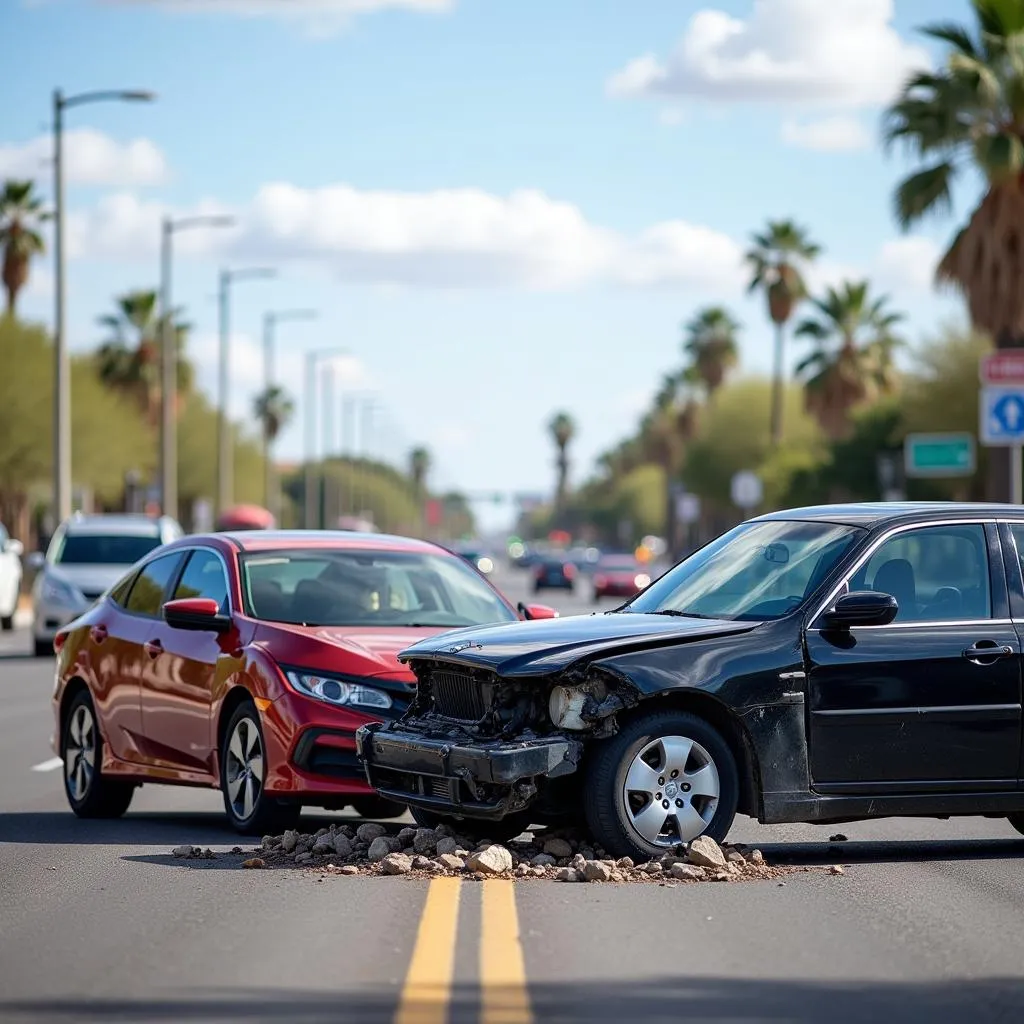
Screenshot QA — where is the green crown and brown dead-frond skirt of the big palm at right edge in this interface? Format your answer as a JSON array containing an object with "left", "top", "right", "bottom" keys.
[{"left": 884, "top": 0, "right": 1024, "bottom": 347}]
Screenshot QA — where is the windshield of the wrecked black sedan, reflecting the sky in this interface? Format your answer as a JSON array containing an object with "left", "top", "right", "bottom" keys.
[{"left": 623, "top": 520, "right": 863, "bottom": 622}]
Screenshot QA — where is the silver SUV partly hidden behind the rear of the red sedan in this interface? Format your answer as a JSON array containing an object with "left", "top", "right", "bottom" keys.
[{"left": 29, "top": 514, "right": 182, "bottom": 657}]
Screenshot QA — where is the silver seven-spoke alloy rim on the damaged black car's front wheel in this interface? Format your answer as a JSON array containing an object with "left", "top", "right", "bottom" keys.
[{"left": 623, "top": 736, "right": 721, "bottom": 847}]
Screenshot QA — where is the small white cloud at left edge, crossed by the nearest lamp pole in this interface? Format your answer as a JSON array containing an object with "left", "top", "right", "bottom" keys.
[{"left": 0, "top": 128, "right": 168, "bottom": 186}]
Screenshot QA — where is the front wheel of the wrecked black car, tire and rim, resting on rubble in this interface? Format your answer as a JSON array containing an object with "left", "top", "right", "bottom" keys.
[{"left": 584, "top": 711, "right": 739, "bottom": 862}]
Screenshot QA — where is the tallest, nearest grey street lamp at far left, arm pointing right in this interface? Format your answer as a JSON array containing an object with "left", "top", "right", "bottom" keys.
[{"left": 53, "top": 83, "right": 157, "bottom": 526}]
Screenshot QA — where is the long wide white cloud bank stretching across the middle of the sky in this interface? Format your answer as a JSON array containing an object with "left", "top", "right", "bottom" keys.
[{"left": 69, "top": 183, "right": 742, "bottom": 294}]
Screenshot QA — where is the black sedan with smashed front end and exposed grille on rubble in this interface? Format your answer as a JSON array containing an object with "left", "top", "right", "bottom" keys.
[{"left": 357, "top": 503, "right": 1024, "bottom": 859}]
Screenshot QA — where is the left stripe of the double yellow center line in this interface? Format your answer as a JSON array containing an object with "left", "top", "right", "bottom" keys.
[{"left": 394, "top": 879, "right": 462, "bottom": 1024}]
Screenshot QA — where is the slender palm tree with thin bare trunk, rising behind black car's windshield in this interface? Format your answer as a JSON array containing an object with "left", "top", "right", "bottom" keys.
[{"left": 746, "top": 220, "right": 821, "bottom": 445}]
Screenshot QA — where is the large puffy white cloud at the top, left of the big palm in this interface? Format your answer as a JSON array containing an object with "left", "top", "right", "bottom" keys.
[{"left": 607, "top": 0, "right": 929, "bottom": 108}]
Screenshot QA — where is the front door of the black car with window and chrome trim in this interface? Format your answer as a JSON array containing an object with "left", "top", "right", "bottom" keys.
[{"left": 806, "top": 521, "right": 1021, "bottom": 794}]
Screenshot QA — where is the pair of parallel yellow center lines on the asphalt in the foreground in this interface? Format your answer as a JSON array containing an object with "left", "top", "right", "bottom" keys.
[{"left": 395, "top": 879, "right": 534, "bottom": 1024}]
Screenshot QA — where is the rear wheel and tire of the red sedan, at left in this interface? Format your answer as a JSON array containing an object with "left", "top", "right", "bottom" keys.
[{"left": 60, "top": 690, "right": 135, "bottom": 818}]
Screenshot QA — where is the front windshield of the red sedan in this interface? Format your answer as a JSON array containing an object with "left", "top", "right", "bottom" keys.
[{"left": 241, "top": 548, "right": 516, "bottom": 629}]
